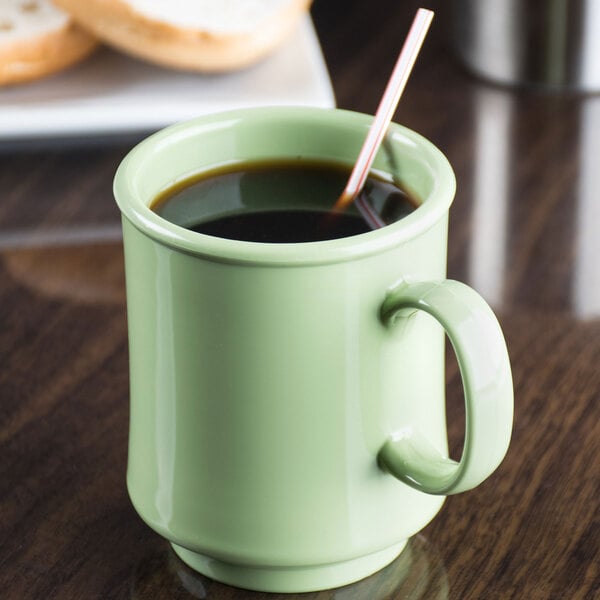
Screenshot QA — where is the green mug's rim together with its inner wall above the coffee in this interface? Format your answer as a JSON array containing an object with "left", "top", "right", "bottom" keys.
[{"left": 115, "top": 108, "right": 455, "bottom": 262}]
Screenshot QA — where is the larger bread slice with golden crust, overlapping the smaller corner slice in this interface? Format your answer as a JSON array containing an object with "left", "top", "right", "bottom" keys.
[{"left": 54, "top": 0, "right": 311, "bottom": 72}]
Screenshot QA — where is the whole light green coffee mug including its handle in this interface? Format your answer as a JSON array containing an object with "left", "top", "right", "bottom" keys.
[{"left": 115, "top": 108, "right": 513, "bottom": 592}]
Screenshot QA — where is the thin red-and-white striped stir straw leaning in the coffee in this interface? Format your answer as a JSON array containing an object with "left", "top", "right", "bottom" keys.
[{"left": 333, "top": 8, "right": 433, "bottom": 228}]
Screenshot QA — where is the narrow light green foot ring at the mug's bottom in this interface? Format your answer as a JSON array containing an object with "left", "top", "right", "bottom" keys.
[{"left": 171, "top": 540, "right": 407, "bottom": 593}]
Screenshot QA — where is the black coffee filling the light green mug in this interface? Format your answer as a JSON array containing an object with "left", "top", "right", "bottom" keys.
[{"left": 151, "top": 160, "right": 418, "bottom": 243}]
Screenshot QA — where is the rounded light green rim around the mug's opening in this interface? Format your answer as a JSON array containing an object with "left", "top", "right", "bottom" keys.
[{"left": 113, "top": 107, "right": 456, "bottom": 266}]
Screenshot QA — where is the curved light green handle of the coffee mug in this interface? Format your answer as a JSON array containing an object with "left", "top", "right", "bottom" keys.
[{"left": 377, "top": 279, "right": 513, "bottom": 495}]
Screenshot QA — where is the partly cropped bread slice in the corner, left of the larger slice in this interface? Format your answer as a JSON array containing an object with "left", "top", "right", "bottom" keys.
[{"left": 0, "top": 0, "right": 97, "bottom": 85}]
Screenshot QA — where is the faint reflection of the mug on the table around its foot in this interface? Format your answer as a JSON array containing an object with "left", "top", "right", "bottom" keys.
[{"left": 131, "top": 535, "right": 449, "bottom": 600}]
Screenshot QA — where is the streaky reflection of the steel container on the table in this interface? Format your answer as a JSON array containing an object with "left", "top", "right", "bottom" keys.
[{"left": 467, "top": 78, "right": 600, "bottom": 319}]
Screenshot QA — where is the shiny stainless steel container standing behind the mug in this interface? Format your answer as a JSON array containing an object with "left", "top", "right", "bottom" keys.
[{"left": 454, "top": 0, "right": 600, "bottom": 92}]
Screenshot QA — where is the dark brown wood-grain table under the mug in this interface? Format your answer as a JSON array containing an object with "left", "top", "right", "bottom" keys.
[{"left": 0, "top": 0, "right": 600, "bottom": 600}]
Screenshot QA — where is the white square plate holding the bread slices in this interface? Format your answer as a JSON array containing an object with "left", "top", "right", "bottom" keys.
[{"left": 0, "top": 16, "right": 335, "bottom": 142}]
